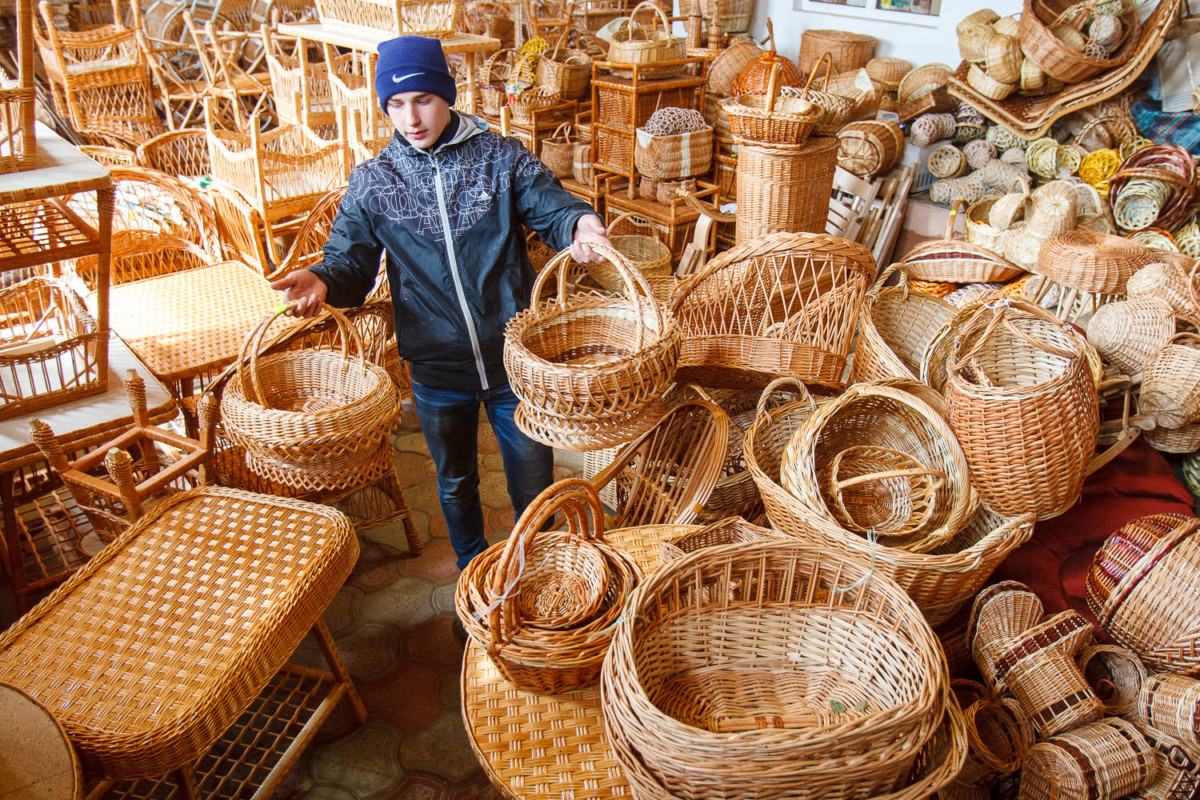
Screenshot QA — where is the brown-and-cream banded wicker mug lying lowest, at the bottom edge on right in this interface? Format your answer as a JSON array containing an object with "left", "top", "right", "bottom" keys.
[{"left": 1021, "top": 717, "right": 1156, "bottom": 800}]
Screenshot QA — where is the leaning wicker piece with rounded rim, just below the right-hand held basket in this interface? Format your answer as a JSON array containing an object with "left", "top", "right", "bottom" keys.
[{"left": 589, "top": 397, "right": 730, "bottom": 529}]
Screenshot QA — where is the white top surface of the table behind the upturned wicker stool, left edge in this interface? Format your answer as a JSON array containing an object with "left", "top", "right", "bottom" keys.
[{"left": 0, "top": 335, "right": 178, "bottom": 474}]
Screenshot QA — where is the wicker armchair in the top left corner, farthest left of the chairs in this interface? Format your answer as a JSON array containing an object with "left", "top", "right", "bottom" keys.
[{"left": 34, "top": 0, "right": 164, "bottom": 146}]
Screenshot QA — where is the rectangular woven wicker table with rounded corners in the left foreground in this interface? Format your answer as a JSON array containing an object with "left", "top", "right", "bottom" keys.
[{"left": 0, "top": 488, "right": 366, "bottom": 799}]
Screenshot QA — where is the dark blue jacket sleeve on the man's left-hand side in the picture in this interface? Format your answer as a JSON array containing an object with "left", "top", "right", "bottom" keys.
[{"left": 310, "top": 169, "right": 383, "bottom": 308}]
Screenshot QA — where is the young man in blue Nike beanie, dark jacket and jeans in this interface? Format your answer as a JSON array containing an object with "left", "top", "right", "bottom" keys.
[{"left": 271, "top": 36, "right": 608, "bottom": 569}]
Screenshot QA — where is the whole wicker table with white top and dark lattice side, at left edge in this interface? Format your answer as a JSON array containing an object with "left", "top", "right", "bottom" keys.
[{"left": 0, "top": 335, "right": 178, "bottom": 610}]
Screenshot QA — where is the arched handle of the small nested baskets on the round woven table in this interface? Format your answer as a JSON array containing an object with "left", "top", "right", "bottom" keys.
[{"left": 486, "top": 477, "right": 604, "bottom": 655}]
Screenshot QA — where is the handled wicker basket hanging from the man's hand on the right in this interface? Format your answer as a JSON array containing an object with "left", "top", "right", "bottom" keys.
[{"left": 504, "top": 245, "right": 679, "bottom": 446}]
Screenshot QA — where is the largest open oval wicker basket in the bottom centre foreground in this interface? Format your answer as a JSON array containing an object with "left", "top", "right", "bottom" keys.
[{"left": 601, "top": 541, "right": 953, "bottom": 800}]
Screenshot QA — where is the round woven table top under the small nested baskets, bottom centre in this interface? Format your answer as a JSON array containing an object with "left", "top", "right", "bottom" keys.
[{"left": 462, "top": 525, "right": 698, "bottom": 800}]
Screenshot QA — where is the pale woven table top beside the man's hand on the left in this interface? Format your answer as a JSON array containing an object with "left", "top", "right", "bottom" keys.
[{"left": 96, "top": 261, "right": 281, "bottom": 380}]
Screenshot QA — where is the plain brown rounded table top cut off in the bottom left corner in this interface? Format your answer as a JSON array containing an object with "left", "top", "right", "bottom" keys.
[{"left": 0, "top": 684, "right": 83, "bottom": 800}]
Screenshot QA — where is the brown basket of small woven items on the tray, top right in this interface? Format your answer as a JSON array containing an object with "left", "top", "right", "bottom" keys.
[{"left": 1018, "top": 0, "right": 1141, "bottom": 84}]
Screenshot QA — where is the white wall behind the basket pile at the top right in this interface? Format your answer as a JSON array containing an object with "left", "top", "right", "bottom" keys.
[{"left": 750, "top": 0, "right": 1021, "bottom": 67}]
